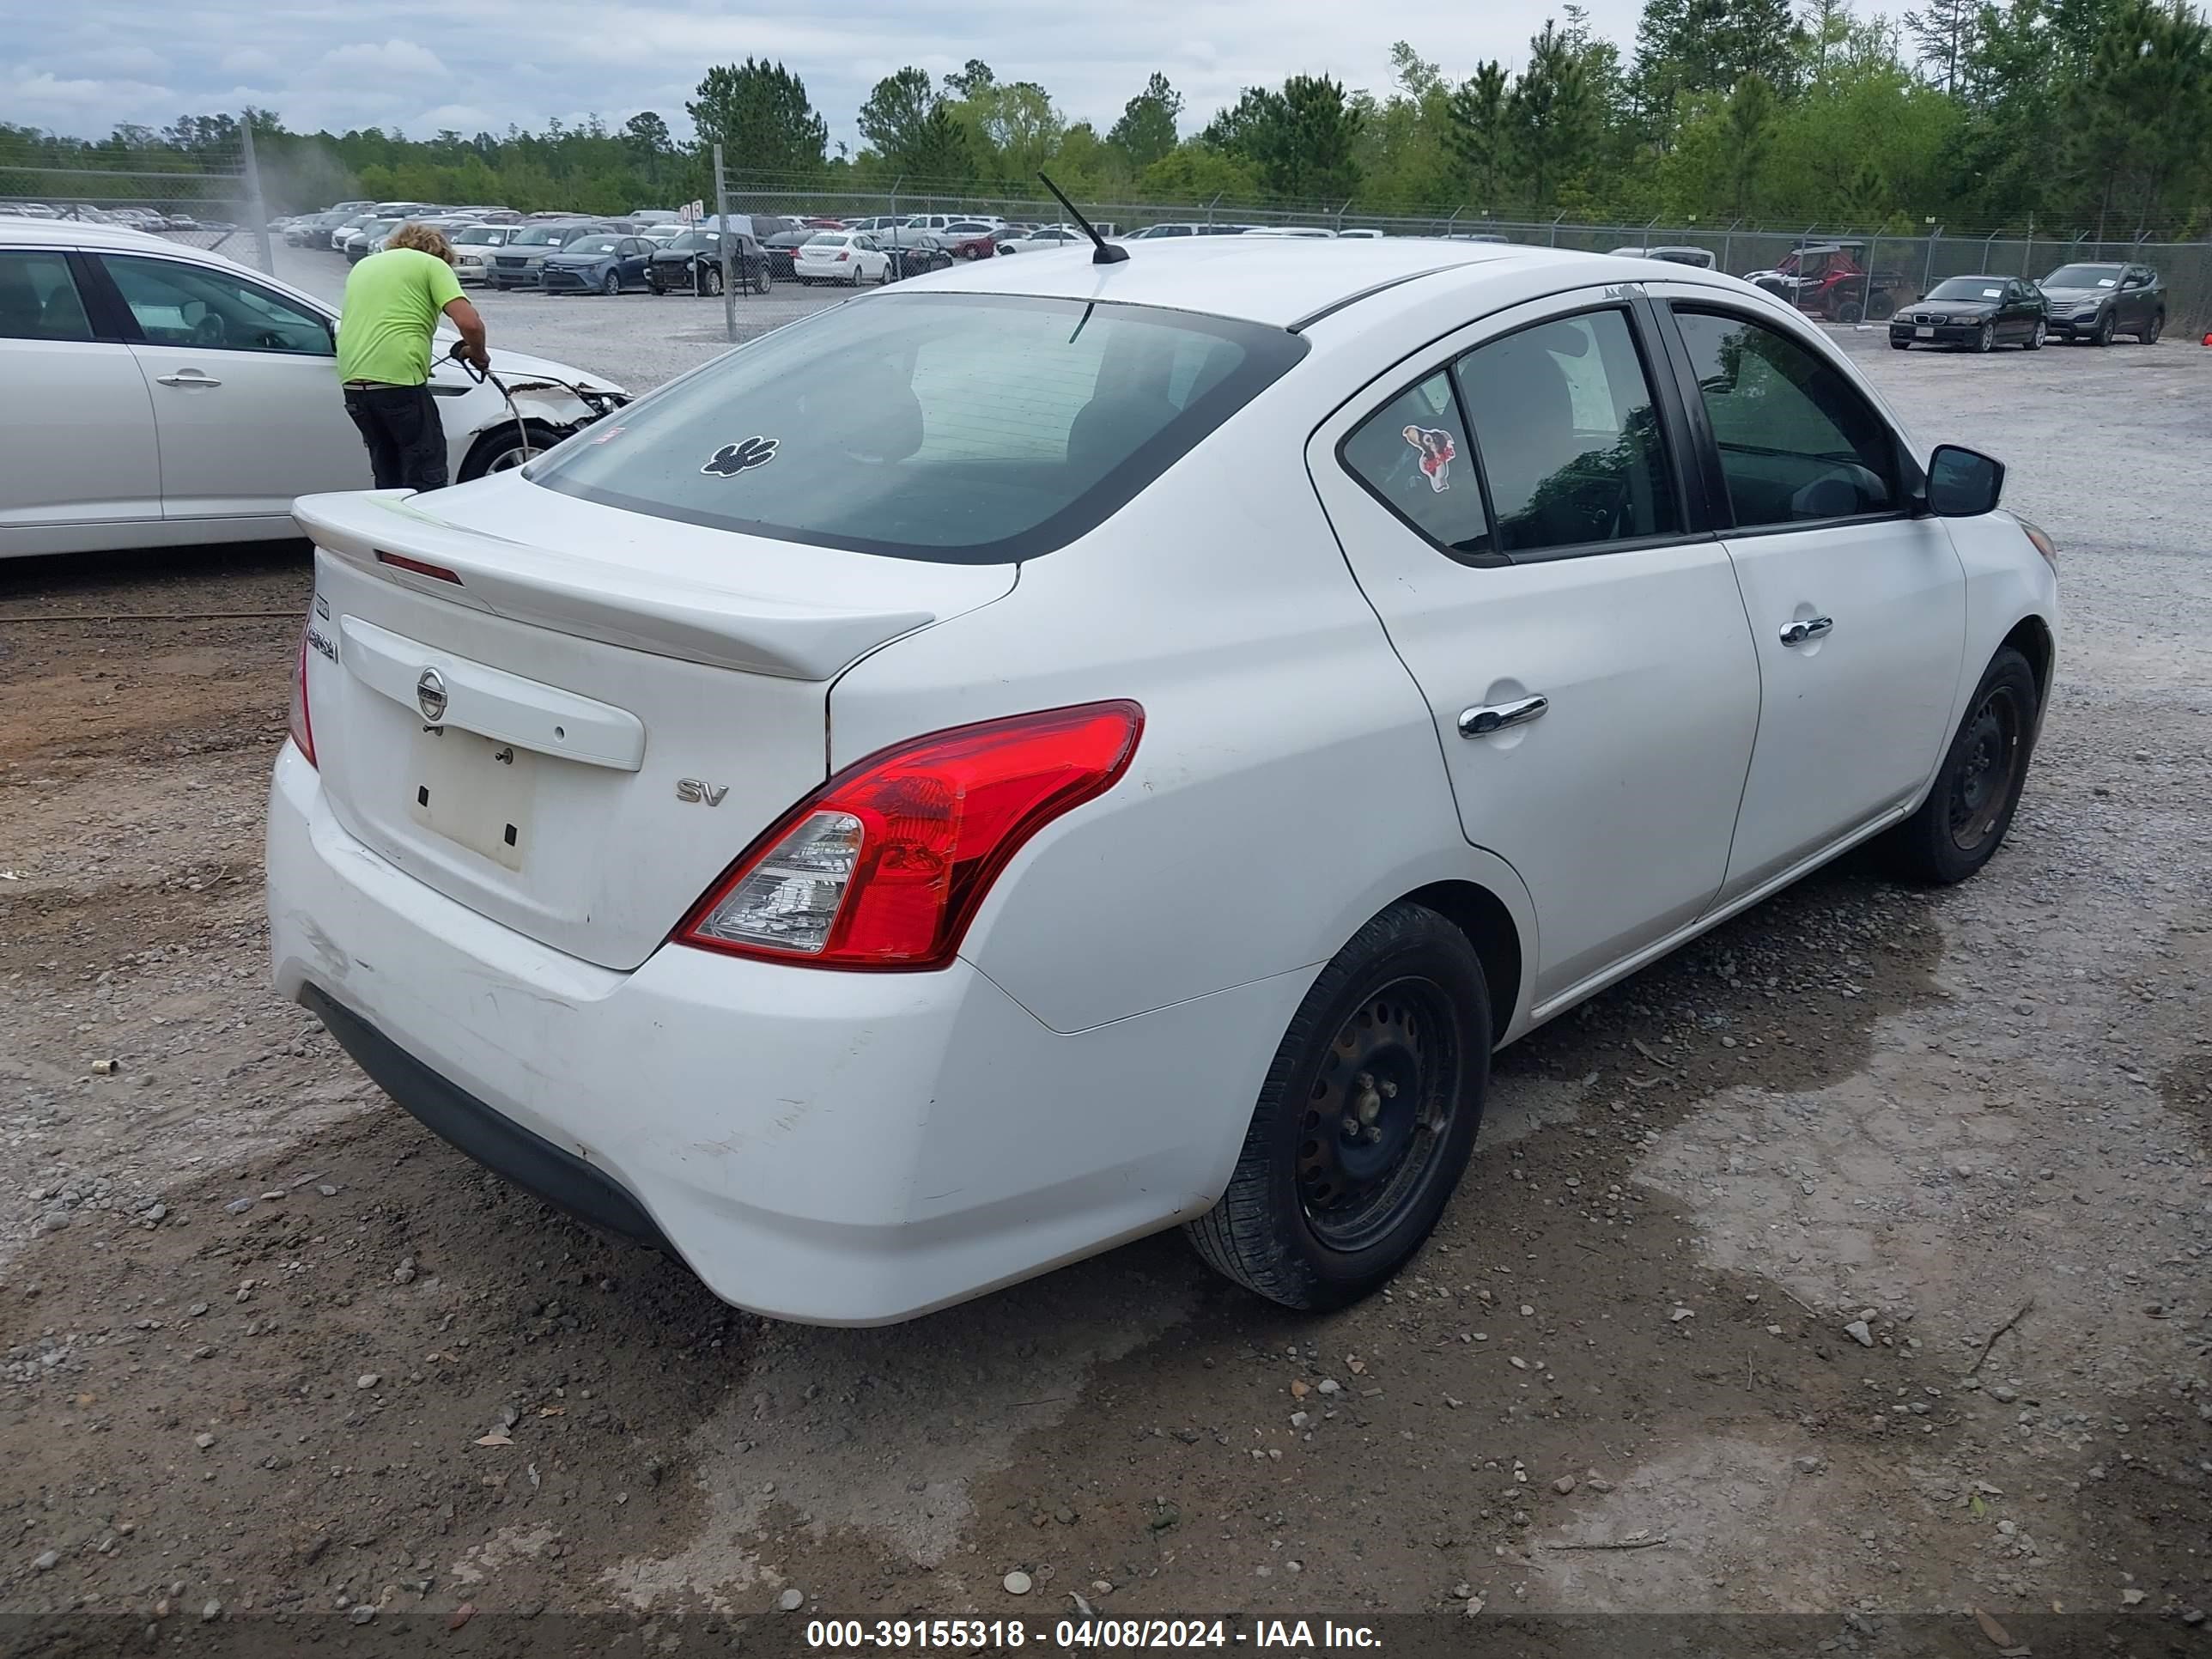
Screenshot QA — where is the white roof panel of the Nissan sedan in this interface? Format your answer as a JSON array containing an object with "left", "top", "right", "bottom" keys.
[{"left": 907, "top": 237, "right": 1637, "bottom": 327}]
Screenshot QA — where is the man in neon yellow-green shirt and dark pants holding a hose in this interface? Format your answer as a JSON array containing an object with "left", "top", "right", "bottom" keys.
[{"left": 338, "top": 223, "right": 491, "bottom": 489}]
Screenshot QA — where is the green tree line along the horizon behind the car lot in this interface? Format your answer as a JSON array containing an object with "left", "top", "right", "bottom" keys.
[{"left": 0, "top": 0, "right": 2212, "bottom": 239}]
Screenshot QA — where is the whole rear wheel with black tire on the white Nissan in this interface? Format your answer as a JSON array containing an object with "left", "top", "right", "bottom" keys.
[{"left": 1186, "top": 902, "right": 1491, "bottom": 1312}]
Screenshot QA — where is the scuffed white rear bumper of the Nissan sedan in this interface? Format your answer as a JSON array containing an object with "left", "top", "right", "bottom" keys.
[{"left": 268, "top": 745, "right": 1312, "bottom": 1325}]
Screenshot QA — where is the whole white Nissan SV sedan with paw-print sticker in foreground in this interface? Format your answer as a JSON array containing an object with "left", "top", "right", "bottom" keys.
[{"left": 268, "top": 237, "right": 2057, "bottom": 1322}]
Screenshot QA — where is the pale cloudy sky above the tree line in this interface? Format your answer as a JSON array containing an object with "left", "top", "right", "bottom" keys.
[{"left": 0, "top": 0, "right": 1641, "bottom": 149}]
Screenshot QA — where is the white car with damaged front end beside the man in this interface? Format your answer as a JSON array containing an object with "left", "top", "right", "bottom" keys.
[{"left": 0, "top": 219, "right": 629, "bottom": 557}]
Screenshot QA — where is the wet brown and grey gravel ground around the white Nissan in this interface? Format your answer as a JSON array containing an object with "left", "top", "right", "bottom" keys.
[{"left": 0, "top": 276, "right": 2212, "bottom": 1650}]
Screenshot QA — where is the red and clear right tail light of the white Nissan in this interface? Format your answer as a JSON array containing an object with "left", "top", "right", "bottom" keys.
[{"left": 675, "top": 702, "right": 1144, "bottom": 969}]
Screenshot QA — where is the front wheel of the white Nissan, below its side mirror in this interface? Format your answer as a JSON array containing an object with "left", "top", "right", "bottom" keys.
[{"left": 1887, "top": 646, "right": 2042, "bottom": 887}]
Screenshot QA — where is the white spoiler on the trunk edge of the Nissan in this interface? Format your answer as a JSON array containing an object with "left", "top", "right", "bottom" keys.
[{"left": 292, "top": 491, "right": 936, "bottom": 679}]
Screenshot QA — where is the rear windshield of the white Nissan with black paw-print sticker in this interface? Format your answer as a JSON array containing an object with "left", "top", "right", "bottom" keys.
[{"left": 529, "top": 295, "right": 1305, "bottom": 564}]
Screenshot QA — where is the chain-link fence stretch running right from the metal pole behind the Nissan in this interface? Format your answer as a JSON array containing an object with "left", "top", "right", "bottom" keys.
[{"left": 730, "top": 175, "right": 2212, "bottom": 337}]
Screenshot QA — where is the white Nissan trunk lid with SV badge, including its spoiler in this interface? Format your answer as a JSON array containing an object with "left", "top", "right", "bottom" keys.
[{"left": 295, "top": 473, "right": 1015, "bottom": 969}]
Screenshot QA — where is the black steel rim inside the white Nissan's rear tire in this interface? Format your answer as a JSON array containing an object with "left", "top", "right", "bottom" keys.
[{"left": 1297, "top": 978, "right": 1460, "bottom": 1255}]
